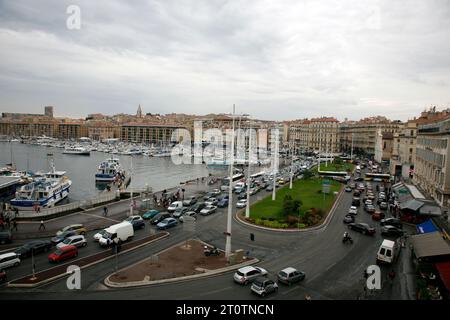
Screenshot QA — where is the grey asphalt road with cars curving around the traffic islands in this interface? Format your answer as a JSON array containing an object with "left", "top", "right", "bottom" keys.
[{"left": 0, "top": 171, "right": 414, "bottom": 300}]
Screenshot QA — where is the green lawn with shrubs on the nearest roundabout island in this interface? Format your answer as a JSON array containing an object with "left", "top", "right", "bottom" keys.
[{"left": 250, "top": 178, "right": 341, "bottom": 219}]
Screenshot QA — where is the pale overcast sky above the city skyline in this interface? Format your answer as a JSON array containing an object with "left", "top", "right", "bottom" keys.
[{"left": 0, "top": 0, "right": 450, "bottom": 120}]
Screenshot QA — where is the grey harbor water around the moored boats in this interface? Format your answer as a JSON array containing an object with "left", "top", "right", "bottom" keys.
[{"left": 0, "top": 142, "right": 209, "bottom": 201}]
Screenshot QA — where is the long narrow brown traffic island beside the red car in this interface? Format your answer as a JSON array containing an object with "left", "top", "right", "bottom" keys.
[{"left": 8, "top": 232, "right": 169, "bottom": 288}]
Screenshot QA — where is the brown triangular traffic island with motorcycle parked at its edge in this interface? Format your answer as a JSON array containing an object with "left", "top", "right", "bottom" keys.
[{"left": 105, "top": 239, "right": 259, "bottom": 288}]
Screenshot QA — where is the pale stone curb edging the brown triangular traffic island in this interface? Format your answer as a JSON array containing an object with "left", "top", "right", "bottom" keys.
[{"left": 103, "top": 239, "right": 260, "bottom": 288}]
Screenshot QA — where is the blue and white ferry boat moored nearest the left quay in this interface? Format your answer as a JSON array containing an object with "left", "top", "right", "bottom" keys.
[{"left": 11, "top": 164, "right": 72, "bottom": 210}]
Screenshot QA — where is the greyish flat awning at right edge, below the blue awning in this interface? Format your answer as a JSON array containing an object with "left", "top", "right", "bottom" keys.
[{"left": 411, "top": 232, "right": 450, "bottom": 259}]
